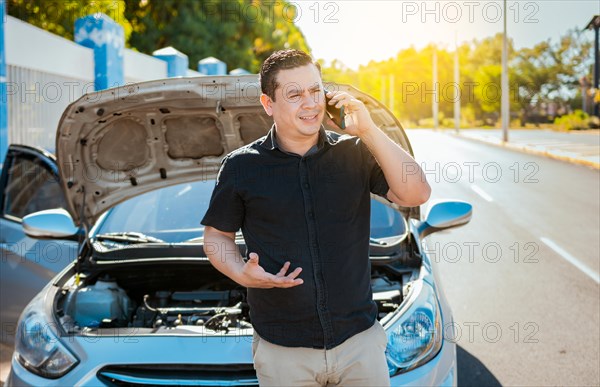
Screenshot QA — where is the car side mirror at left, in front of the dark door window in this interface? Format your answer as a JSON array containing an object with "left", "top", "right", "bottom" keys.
[{"left": 23, "top": 208, "right": 79, "bottom": 240}]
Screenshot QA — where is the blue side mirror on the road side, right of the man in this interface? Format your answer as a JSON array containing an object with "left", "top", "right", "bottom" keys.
[{"left": 419, "top": 201, "right": 473, "bottom": 238}]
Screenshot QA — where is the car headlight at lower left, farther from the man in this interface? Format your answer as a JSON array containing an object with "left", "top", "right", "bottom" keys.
[{"left": 15, "top": 298, "right": 79, "bottom": 379}]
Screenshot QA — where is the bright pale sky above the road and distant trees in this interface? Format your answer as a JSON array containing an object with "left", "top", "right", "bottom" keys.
[{"left": 292, "top": 0, "right": 600, "bottom": 69}]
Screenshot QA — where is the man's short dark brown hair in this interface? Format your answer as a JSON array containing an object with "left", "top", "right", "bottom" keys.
[{"left": 258, "top": 50, "right": 321, "bottom": 101}]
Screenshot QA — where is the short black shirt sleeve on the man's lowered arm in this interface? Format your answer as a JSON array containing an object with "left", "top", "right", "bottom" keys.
[{"left": 200, "top": 156, "right": 244, "bottom": 232}]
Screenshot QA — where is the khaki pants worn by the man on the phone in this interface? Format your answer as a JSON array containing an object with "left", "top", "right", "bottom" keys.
[{"left": 252, "top": 321, "right": 390, "bottom": 386}]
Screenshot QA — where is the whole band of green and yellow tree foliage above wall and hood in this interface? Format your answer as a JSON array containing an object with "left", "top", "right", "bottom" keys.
[{"left": 7, "top": 0, "right": 310, "bottom": 72}]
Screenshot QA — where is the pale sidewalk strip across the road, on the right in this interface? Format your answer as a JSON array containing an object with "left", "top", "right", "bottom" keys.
[{"left": 440, "top": 129, "right": 600, "bottom": 169}]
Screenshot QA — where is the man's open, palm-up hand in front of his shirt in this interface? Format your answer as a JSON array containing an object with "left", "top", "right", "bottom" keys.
[{"left": 238, "top": 253, "right": 304, "bottom": 289}]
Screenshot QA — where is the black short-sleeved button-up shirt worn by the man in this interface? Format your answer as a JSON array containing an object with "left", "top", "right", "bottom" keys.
[{"left": 202, "top": 127, "right": 389, "bottom": 349}]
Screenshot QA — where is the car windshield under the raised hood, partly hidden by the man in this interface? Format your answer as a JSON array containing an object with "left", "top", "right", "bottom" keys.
[{"left": 96, "top": 180, "right": 405, "bottom": 243}]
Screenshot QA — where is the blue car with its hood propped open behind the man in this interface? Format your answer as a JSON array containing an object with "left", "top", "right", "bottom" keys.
[{"left": 1, "top": 75, "right": 472, "bottom": 386}]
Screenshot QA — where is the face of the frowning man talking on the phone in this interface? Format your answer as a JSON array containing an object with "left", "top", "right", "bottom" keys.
[{"left": 261, "top": 64, "right": 325, "bottom": 140}]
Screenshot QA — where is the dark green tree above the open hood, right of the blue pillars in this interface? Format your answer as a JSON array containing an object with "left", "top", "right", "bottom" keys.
[{"left": 125, "top": 0, "right": 310, "bottom": 72}]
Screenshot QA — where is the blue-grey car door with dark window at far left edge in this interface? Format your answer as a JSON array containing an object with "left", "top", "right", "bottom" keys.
[{"left": 0, "top": 145, "right": 78, "bottom": 343}]
